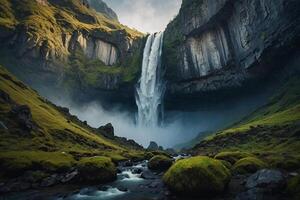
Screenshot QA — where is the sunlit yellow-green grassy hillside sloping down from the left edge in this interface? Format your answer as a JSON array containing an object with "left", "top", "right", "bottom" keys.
[{"left": 0, "top": 67, "right": 144, "bottom": 178}]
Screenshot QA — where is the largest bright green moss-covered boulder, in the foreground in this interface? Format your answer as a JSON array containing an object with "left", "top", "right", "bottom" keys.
[{"left": 163, "top": 156, "right": 231, "bottom": 196}]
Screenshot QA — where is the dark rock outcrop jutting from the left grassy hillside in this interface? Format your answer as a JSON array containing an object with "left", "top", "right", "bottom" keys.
[{"left": 10, "top": 105, "right": 34, "bottom": 131}]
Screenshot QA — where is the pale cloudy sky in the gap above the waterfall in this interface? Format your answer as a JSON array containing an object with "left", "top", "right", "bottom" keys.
[{"left": 104, "top": 0, "right": 182, "bottom": 33}]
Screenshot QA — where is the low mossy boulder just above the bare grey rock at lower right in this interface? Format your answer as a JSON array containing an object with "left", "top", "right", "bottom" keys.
[{"left": 232, "top": 157, "right": 268, "bottom": 174}]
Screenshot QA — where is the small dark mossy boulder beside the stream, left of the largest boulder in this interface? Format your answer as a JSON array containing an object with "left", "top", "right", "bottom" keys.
[{"left": 148, "top": 155, "right": 173, "bottom": 171}]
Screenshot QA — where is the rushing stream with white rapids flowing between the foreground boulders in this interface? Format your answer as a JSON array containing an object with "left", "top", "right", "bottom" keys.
[{"left": 57, "top": 161, "right": 166, "bottom": 200}]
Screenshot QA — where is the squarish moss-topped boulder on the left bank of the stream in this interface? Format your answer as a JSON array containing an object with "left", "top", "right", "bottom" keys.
[{"left": 78, "top": 157, "right": 117, "bottom": 183}]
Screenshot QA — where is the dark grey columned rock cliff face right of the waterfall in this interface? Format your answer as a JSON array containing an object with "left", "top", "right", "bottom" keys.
[{"left": 163, "top": 0, "right": 300, "bottom": 94}]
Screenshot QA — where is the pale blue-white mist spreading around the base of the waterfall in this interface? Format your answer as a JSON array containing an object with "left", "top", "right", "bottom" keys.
[{"left": 47, "top": 88, "right": 269, "bottom": 148}]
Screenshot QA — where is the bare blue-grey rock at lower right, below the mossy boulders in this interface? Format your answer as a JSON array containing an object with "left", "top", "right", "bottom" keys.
[{"left": 246, "top": 169, "right": 286, "bottom": 190}]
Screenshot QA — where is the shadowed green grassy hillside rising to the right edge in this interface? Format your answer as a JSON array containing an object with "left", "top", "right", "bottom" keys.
[{"left": 192, "top": 75, "right": 300, "bottom": 170}]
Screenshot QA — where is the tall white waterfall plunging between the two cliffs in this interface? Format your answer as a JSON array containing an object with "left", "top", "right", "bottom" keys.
[{"left": 136, "top": 32, "right": 166, "bottom": 126}]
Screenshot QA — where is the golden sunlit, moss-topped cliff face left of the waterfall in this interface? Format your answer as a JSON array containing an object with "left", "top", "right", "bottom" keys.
[{"left": 0, "top": 0, "right": 144, "bottom": 101}]
